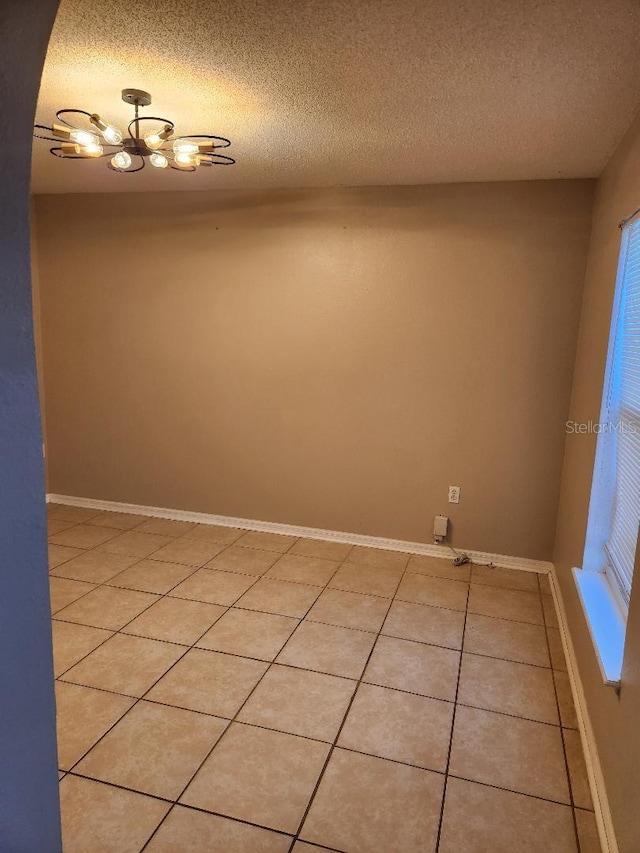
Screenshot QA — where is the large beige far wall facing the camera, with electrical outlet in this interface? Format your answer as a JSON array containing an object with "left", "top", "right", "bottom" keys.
[{"left": 36, "top": 181, "right": 593, "bottom": 559}]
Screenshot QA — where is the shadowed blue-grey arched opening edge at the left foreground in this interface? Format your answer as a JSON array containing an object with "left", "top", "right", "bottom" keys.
[{"left": 0, "top": 0, "right": 61, "bottom": 853}]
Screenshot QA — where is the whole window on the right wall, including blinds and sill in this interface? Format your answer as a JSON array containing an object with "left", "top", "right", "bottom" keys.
[{"left": 575, "top": 222, "right": 640, "bottom": 683}]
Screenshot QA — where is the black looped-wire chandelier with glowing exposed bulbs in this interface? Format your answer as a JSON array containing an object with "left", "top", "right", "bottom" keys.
[{"left": 33, "top": 89, "right": 235, "bottom": 172}]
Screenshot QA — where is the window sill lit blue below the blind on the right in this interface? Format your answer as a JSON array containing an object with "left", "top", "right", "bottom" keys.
[{"left": 573, "top": 568, "right": 626, "bottom": 689}]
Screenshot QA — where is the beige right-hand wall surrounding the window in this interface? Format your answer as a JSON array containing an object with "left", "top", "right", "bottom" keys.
[{"left": 555, "top": 119, "right": 640, "bottom": 853}]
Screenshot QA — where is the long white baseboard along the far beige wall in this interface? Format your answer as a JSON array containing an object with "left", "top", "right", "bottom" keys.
[{"left": 47, "top": 495, "right": 553, "bottom": 574}]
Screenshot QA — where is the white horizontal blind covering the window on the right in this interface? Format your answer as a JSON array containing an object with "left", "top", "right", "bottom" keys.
[{"left": 598, "top": 222, "right": 640, "bottom": 606}]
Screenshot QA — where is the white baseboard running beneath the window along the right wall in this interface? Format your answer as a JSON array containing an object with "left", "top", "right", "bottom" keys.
[{"left": 549, "top": 568, "right": 618, "bottom": 853}]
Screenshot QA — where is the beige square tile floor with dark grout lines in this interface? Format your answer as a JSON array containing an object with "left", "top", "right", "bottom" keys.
[{"left": 49, "top": 505, "right": 600, "bottom": 853}]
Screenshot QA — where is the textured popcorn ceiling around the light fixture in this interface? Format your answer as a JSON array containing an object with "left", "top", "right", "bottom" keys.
[{"left": 33, "top": 0, "right": 640, "bottom": 192}]
